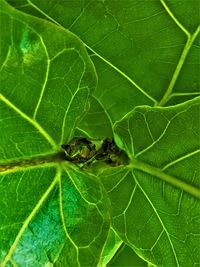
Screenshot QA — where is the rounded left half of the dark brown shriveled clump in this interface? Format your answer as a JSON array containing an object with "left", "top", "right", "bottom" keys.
[{"left": 61, "top": 137, "right": 96, "bottom": 163}]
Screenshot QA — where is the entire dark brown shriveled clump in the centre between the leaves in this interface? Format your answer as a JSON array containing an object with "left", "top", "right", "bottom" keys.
[{"left": 62, "top": 137, "right": 129, "bottom": 166}]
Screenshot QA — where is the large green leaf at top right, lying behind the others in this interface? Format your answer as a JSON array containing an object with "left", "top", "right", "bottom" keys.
[{"left": 6, "top": 0, "right": 200, "bottom": 138}]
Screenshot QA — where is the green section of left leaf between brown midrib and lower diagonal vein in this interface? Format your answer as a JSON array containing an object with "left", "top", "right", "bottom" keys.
[{"left": 0, "top": 167, "right": 56, "bottom": 262}]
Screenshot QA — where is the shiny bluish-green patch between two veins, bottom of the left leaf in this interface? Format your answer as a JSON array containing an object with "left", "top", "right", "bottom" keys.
[{"left": 13, "top": 187, "right": 65, "bottom": 266}]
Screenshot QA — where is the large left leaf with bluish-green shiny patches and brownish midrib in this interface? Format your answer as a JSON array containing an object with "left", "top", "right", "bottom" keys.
[{"left": 0, "top": 0, "right": 110, "bottom": 267}]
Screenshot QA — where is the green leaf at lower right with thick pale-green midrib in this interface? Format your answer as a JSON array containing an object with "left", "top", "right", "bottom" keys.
[{"left": 101, "top": 98, "right": 200, "bottom": 267}]
